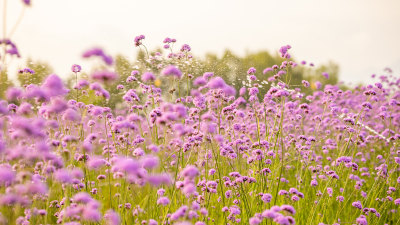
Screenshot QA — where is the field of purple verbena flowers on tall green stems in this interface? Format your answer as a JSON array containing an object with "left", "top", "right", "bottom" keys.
[{"left": 0, "top": 34, "right": 400, "bottom": 225}]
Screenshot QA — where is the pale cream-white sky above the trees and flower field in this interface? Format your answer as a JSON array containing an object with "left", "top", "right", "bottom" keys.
[{"left": 0, "top": 0, "right": 400, "bottom": 84}]
